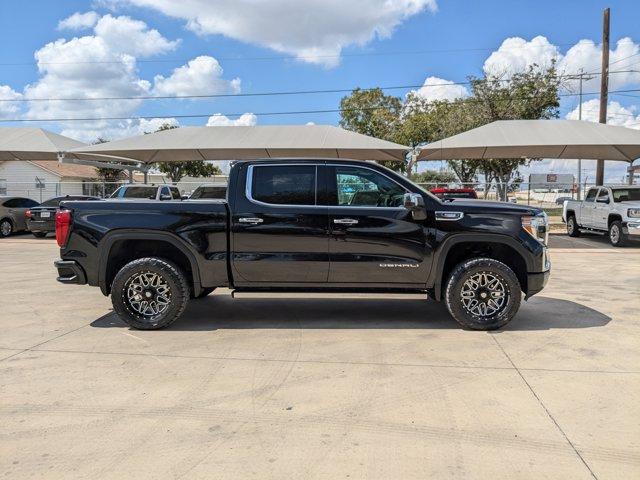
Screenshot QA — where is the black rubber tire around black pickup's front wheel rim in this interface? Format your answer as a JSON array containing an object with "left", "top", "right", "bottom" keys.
[{"left": 445, "top": 258, "right": 522, "bottom": 330}]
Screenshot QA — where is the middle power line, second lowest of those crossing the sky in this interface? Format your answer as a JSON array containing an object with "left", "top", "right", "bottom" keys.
[{"left": 0, "top": 70, "right": 632, "bottom": 103}]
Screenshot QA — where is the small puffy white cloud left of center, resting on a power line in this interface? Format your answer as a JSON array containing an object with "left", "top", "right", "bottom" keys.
[{"left": 154, "top": 56, "right": 240, "bottom": 95}]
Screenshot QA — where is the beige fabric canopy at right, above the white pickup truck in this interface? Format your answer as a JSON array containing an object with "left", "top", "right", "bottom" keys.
[{"left": 418, "top": 120, "right": 640, "bottom": 162}]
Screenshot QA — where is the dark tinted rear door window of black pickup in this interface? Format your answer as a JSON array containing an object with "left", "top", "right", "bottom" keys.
[{"left": 249, "top": 165, "right": 316, "bottom": 205}]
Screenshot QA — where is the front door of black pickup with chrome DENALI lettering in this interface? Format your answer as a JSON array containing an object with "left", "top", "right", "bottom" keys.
[{"left": 326, "top": 164, "right": 432, "bottom": 287}]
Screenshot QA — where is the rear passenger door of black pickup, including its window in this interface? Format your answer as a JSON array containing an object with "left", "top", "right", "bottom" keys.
[{"left": 231, "top": 162, "right": 329, "bottom": 286}]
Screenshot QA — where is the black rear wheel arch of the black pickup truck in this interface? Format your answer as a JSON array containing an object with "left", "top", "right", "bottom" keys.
[{"left": 98, "top": 230, "right": 202, "bottom": 295}]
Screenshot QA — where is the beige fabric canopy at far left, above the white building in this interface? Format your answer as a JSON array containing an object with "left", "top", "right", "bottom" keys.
[{"left": 0, "top": 127, "right": 86, "bottom": 160}]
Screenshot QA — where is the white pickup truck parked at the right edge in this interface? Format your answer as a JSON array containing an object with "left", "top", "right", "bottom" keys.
[{"left": 562, "top": 186, "right": 640, "bottom": 247}]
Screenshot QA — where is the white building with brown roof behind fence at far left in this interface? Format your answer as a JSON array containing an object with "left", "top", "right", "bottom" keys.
[{"left": 0, "top": 160, "right": 99, "bottom": 202}]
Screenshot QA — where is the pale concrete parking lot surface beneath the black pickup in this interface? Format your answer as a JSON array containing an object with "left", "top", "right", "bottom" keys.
[{"left": 0, "top": 235, "right": 640, "bottom": 479}]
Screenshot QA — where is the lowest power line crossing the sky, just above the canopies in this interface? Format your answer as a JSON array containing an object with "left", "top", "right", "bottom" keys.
[{"left": 0, "top": 89, "right": 640, "bottom": 123}]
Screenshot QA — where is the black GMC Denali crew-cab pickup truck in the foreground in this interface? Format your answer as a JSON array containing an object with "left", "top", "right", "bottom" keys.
[{"left": 55, "top": 159, "right": 550, "bottom": 330}]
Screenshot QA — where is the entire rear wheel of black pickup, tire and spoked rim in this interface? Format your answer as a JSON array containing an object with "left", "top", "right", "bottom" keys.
[{"left": 111, "top": 257, "right": 191, "bottom": 330}]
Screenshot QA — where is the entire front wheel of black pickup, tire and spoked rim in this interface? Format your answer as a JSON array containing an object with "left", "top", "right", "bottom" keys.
[{"left": 445, "top": 258, "right": 521, "bottom": 330}]
